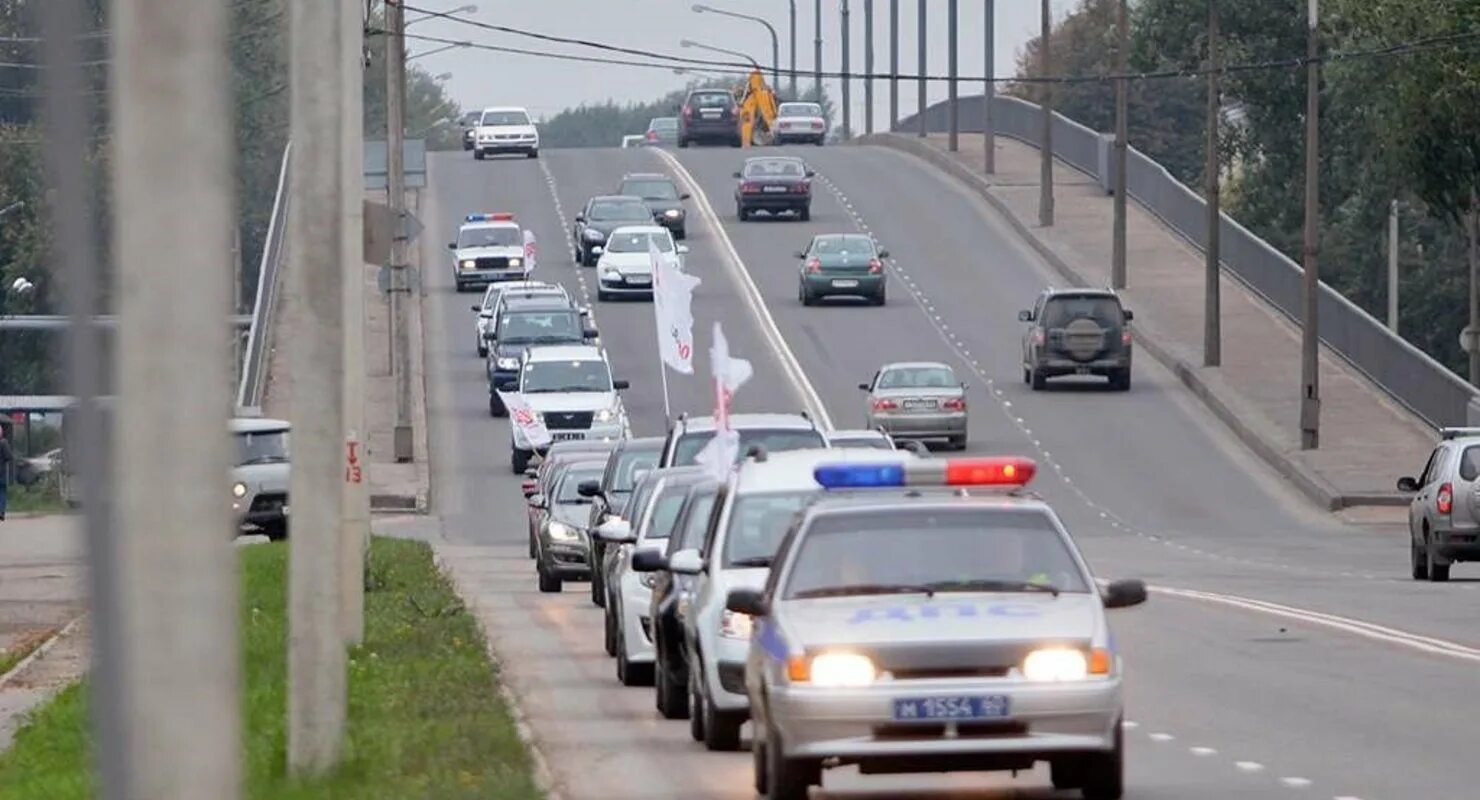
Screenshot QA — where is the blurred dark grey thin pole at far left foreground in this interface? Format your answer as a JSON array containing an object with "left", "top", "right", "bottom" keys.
[{"left": 40, "top": 0, "right": 124, "bottom": 800}]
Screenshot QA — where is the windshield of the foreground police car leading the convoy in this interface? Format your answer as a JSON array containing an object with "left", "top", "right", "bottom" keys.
[{"left": 784, "top": 509, "right": 1089, "bottom": 599}]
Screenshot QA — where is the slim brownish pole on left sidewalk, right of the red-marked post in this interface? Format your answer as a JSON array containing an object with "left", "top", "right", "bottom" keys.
[{"left": 385, "top": 0, "right": 413, "bottom": 463}]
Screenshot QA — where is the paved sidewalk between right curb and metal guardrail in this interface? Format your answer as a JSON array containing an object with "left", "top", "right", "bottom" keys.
[{"left": 858, "top": 133, "right": 1436, "bottom": 510}]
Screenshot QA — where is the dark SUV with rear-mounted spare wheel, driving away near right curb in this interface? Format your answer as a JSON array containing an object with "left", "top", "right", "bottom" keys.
[{"left": 1018, "top": 288, "right": 1134, "bottom": 392}]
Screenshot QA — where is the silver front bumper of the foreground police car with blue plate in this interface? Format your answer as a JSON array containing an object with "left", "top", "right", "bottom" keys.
[{"left": 767, "top": 680, "right": 1122, "bottom": 769}]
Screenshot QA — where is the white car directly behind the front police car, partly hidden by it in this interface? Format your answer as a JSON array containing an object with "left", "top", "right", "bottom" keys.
[{"left": 667, "top": 442, "right": 915, "bottom": 750}]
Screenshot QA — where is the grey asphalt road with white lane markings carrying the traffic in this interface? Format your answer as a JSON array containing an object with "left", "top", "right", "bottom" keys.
[{"left": 423, "top": 148, "right": 1480, "bottom": 800}]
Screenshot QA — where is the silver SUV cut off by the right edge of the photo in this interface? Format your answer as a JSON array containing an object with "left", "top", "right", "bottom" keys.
[{"left": 1397, "top": 427, "right": 1480, "bottom": 581}]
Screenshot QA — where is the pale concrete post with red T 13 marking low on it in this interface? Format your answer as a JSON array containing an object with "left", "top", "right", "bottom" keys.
[{"left": 337, "top": 0, "right": 370, "bottom": 645}]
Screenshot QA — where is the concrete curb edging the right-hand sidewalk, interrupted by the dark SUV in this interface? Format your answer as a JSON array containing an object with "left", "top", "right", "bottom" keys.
[{"left": 850, "top": 133, "right": 1373, "bottom": 512}]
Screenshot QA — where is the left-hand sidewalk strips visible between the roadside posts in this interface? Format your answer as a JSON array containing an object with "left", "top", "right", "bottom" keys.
[{"left": 262, "top": 191, "right": 431, "bottom": 513}]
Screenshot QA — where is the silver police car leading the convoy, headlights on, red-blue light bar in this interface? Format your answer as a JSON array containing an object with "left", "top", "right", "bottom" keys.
[{"left": 725, "top": 454, "right": 1146, "bottom": 800}]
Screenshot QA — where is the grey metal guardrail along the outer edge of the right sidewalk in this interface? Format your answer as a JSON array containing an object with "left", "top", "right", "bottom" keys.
[{"left": 894, "top": 95, "right": 1480, "bottom": 427}]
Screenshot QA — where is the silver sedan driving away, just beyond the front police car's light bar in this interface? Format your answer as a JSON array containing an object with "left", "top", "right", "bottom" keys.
[{"left": 858, "top": 361, "right": 966, "bottom": 450}]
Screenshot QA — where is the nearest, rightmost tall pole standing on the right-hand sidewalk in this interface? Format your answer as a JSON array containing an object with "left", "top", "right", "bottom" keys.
[{"left": 1299, "top": 0, "right": 1326, "bottom": 450}]
